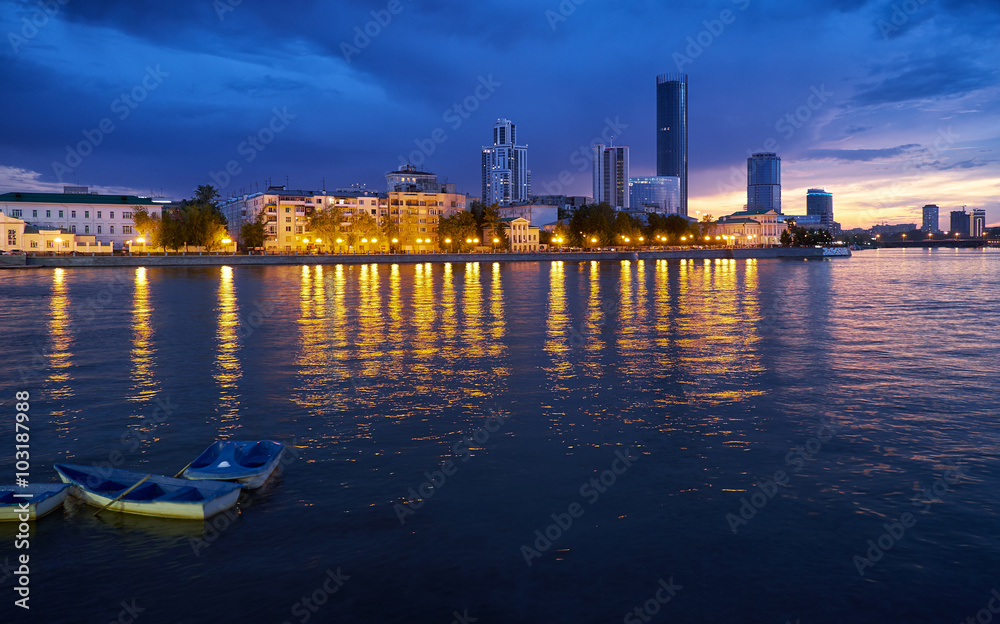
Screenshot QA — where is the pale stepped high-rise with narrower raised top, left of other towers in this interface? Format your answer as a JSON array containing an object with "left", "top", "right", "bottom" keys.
[{"left": 483, "top": 119, "right": 529, "bottom": 206}]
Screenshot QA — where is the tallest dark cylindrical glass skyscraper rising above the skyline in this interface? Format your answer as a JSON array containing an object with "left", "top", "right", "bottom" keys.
[{"left": 656, "top": 74, "right": 688, "bottom": 215}]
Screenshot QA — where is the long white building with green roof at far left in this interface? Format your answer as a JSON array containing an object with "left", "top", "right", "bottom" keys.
[{"left": 0, "top": 187, "right": 169, "bottom": 251}]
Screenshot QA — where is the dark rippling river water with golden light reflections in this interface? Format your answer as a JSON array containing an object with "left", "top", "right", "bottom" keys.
[{"left": 0, "top": 250, "right": 1000, "bottom": 624}]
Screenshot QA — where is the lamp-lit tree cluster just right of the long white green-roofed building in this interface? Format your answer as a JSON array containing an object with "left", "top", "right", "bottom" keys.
[{"left": 132, "top": 184, "right": 226, "bottom": 251}]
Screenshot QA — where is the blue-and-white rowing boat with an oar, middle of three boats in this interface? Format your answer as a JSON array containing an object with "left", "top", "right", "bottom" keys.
[{"left": 55, "top": 464, "right": 242, "bottom": 520}]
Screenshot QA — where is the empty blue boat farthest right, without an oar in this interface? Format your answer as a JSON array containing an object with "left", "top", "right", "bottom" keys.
[{"left": 181, "top": 440, "right": 285, "bottom": 489}]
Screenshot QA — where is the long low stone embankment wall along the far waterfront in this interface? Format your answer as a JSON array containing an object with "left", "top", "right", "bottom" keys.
[{"left": 0, "top": 247, "right": 851, "bottom": 268}]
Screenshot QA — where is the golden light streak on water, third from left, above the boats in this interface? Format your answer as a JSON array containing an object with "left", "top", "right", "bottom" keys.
[{"left": 213, "top": 266, "right": 243, "bottom": 431}]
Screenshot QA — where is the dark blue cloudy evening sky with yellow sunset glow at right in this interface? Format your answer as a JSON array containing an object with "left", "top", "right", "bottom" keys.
[{"left": 0, "top": 0, "right": 1000, "bottom": 228}]
